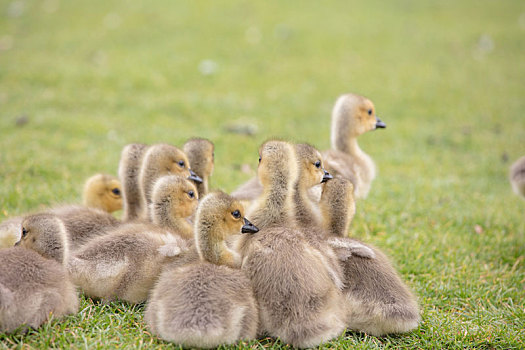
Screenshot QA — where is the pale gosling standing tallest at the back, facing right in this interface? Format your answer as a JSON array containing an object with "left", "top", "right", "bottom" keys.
[{"left": 323, "top": 94, "right": 386, "bottom": 198}]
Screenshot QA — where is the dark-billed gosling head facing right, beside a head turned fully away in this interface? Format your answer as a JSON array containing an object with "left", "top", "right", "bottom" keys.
[{"left": 295, "top": 143, "right": 333, "bottom": 189}]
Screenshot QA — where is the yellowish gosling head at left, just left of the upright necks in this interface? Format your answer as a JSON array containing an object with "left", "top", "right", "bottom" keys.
[{"left": 83, "top": 174, "right": 122, "bottom": 213}]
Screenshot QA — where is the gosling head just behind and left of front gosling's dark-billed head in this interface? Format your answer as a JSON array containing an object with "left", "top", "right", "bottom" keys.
[{"left": 150, "top": 175, "right": 198, "bottom": 224}]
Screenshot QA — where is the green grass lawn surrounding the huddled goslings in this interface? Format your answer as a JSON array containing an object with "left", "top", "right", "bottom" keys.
[{"left": 0, "top": 0, "right": 525, "bottom": 349}]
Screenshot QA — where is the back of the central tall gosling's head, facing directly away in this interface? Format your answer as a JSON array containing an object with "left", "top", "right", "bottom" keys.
[{"left": 257, "top": 140, "right": 299, "bottom": 190}]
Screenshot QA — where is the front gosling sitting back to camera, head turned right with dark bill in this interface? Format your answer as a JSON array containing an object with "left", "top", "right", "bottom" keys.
[{"left": 144, "top": 192, "right": 258, "bottom": 348}]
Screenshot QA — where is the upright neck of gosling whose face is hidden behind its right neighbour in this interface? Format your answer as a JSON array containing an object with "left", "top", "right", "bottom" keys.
[{"left": 118, "top": 143, "right": 148, "bottom": 221}]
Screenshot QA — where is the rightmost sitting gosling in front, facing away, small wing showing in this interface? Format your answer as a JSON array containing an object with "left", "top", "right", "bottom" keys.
[{"left": 320, "top": 178, "right": 420, "bottom": 336}]
